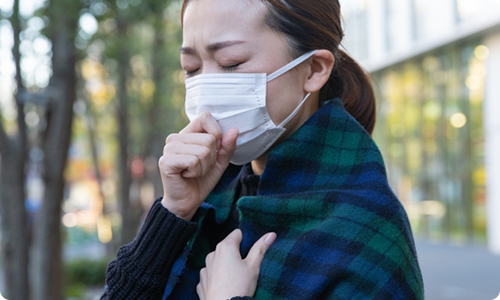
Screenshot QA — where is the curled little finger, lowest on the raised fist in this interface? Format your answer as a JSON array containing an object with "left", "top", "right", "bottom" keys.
[{"left": 159, "top": 155, "right": 202, "bottom": 178}]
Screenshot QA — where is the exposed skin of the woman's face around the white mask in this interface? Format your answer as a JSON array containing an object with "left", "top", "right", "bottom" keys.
[{"left": 181, "top": 0, "right": 317, "bottom": 136}]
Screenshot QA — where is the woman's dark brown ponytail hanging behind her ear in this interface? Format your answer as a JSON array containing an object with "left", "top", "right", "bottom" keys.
[{"left": 319, "top": 50, "right": 376, "bottom": 134}]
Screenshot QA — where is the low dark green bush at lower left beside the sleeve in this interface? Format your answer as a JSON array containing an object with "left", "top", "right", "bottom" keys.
[{"left": 65, "top": 259, "right": 110, "bottom": 292}]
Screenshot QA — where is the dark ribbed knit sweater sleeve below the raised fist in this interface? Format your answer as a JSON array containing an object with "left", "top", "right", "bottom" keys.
[{"left": 101, "top": 198, "right": 197, "bottom": 300}]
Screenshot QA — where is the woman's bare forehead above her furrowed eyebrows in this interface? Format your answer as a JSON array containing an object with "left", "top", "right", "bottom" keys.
[{"left": 183, "top": 0, "right": 266, "bottom": 46}]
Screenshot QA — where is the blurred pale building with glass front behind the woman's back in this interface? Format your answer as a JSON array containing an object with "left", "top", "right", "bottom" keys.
[{"left": 341, "top": 0, "right": 500, "bottom": 253}]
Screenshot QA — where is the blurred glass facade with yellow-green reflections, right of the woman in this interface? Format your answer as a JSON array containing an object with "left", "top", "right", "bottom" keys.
[{"left": 374, "top": 40, "right": 488, "bottom": 243}]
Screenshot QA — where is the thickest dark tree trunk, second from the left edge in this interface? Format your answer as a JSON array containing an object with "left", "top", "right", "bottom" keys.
[{"left": 32, "top": 1, "right": 79, "bottom": 300}]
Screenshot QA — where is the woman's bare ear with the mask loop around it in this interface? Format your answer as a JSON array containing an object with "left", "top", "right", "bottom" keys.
[{"left": 304, "top": 50, "right": 335, "bottom": 93}]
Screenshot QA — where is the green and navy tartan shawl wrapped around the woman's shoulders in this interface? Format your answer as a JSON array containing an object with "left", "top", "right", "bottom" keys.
[{"left": 163, "top": 99, "right": 424, "bottom": 300}]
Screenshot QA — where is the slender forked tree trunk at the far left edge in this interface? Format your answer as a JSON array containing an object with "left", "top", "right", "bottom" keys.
[{"left": 0, "top": 0, "right": 29, "bottom": 300}]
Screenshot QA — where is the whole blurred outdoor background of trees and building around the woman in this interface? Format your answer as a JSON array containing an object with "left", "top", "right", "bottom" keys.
[{"left": 0, "top": 0, "right": 500, "bottom": 300}]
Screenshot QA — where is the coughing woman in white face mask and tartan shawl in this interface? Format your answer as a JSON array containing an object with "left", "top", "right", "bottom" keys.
[{"left": 102, "top": 0, "right": 423, "bottom": 300}]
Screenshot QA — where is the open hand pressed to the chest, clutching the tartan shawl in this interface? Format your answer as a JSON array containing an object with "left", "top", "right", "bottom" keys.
[{"left": 196, "top": 229, "right": 276, "bottom": 300}]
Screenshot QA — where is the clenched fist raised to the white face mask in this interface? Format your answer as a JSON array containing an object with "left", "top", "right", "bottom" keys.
[{"left": 158, "top": 112, "right": 239, "bottom": 221}]
